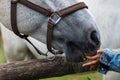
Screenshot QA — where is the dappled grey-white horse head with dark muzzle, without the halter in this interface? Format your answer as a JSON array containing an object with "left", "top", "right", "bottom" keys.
[{"left": 0, "top": 0, "right": 100, "bottom": 62}]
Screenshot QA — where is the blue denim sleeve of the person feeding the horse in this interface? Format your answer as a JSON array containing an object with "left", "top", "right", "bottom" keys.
[{"left": 98, "top": 49, "right": 120, "bottom": 74}]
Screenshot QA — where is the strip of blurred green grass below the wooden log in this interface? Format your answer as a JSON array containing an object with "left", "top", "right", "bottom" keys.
[{"left": 41, "top": 72, "right": 102, "bottom": 80}]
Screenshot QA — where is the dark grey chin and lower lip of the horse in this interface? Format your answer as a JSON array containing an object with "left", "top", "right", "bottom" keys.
[{"left": 65, "top": 50, "right": 85, "bottom": 63}]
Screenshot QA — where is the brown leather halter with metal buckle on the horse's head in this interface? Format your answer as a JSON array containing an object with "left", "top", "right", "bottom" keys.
[{"left": 11, "top": 0, "right": 88, "bottom": 55}]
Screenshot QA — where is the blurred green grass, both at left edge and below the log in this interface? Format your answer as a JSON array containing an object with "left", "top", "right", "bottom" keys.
[{"left": 0, "top": 34, "right": 102, "bottom": 80}]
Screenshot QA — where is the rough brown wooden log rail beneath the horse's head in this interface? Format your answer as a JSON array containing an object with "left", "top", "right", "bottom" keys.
[{"left": 0, "top": 57, "right": 88, "bottom": 80}]
